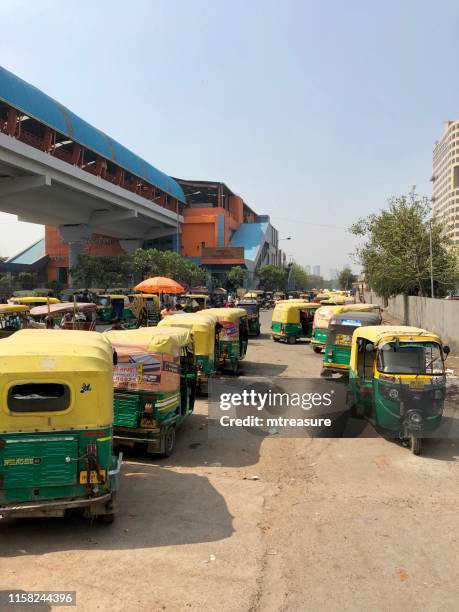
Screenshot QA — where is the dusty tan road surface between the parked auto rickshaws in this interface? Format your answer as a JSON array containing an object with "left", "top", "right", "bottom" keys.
[{"left": 0, "top": 313, "right": 459, "bottom": 612}]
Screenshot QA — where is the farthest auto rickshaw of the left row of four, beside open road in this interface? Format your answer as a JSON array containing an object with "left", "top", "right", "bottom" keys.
[{"left": 206, "top": 308, "right": 249, "bottom": 375}]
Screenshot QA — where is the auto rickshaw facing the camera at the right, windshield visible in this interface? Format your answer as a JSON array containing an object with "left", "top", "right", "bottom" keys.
[{"left": 347, "top": 325, "right": 449, "bottom": 455}]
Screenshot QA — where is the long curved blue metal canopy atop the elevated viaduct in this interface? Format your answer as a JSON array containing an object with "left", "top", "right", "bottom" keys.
[{"left": 0, "top": 66, "right": 185, "bottom": 202}]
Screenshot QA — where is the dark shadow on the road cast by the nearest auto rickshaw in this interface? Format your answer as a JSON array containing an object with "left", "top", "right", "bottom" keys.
[{"left": 0, "top": 463, "right": 234, "bottom": 557}]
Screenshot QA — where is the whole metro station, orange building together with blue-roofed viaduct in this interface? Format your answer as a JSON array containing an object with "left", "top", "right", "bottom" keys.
[{"left": 0, "top": 67, "right": 282, "bottom": 286}]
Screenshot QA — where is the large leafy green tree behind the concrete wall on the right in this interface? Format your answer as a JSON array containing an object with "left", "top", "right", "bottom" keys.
[{"left": 350, "top": 189, "right": 458, "bottom": 297}]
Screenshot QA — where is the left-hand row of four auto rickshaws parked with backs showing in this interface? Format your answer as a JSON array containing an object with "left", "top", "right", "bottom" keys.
[{"left": 0, "top": 308, "right": 252, "bottom": 522}]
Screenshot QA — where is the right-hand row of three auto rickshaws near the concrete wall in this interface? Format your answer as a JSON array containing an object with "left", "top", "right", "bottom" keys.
[{"left": 271, "top": 300, "right": 450, "bottom": 454}]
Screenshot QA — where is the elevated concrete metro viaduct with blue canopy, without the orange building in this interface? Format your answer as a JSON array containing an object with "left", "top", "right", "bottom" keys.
[{"left": 0, "top": 67, "right": 186, "bottom": 284}]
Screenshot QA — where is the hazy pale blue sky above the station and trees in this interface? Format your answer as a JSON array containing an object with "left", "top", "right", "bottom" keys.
[{"left": 0, "top": 0, "right": 459, "bottom": 274}]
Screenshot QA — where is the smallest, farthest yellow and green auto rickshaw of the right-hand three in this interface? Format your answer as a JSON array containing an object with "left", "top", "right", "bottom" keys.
[{"left": 271, "top": 300, "right": 320, "bottom": 344}]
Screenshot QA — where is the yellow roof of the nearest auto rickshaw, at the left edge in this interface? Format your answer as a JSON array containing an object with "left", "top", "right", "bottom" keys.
[{"left": 0, "top": 329, "right": 113, "bottom": 364}]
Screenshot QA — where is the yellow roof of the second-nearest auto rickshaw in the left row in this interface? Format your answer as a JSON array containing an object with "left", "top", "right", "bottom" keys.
[{"left": 103, "top": 327, "right": 193, "bottom": 355}]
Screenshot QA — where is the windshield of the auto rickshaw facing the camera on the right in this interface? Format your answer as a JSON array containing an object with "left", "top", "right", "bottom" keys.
[{"left": 377, "top": 340, "right": 445, "bottom": 376}]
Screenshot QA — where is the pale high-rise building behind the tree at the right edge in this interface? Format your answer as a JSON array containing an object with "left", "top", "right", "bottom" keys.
[{"left": 430, "top": 119, "right": 459, "bottom": 243}]
